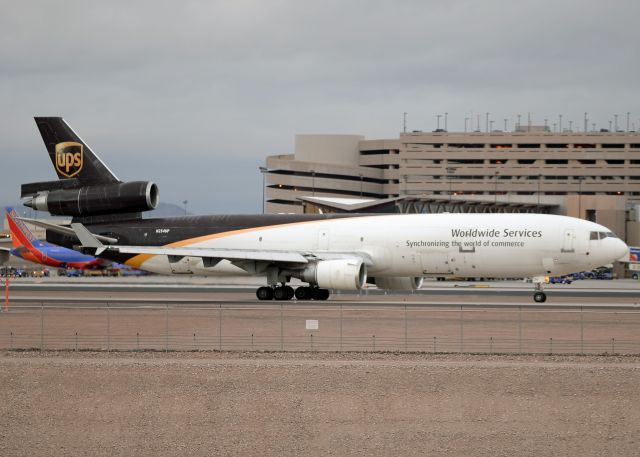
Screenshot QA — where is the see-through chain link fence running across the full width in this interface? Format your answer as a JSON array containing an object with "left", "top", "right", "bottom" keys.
[{"left": 0, "top": 303, "right": 640, "bottom": 354}]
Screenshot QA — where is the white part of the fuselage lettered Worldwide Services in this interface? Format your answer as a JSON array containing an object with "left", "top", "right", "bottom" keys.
[{"left": 134, "top": 213, "right": 628, "bottom": 278}]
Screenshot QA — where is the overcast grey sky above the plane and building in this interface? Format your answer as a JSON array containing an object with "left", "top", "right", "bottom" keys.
[{"left": 0, "top": 0, "right": 640, "bottom": 214}]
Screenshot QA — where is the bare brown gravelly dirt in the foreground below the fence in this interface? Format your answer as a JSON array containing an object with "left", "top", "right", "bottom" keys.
[{"left": 0, "top": 352, "right": 640, "bottom": 456}]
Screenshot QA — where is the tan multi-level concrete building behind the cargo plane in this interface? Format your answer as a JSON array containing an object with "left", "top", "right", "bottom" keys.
[{"left": 262, "top": 126, "right": 640, "bottom": 245}]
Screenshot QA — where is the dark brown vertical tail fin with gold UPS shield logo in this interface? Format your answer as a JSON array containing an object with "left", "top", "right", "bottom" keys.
[{"left": 34, "top": 117, "right": 120, "bottom": 186}]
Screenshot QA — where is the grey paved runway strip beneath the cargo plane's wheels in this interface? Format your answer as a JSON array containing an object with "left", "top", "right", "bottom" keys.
[{"left": 5, "top": 277, "right": 640, "bottom": 309}]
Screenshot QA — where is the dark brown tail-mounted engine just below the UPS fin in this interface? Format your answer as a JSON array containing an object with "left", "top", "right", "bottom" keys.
[{"left": 24, "top": 181, "right": 158, "bottom": 216}]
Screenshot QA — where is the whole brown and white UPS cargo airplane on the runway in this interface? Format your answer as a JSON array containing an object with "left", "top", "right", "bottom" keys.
[{"left": 22, "top": 117, "right": 628, "bottom": 302}]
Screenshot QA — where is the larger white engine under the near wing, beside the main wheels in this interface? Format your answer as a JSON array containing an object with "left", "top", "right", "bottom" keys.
[{"left": 297, "top": 259, "right": 367, "bottom": 290}]
